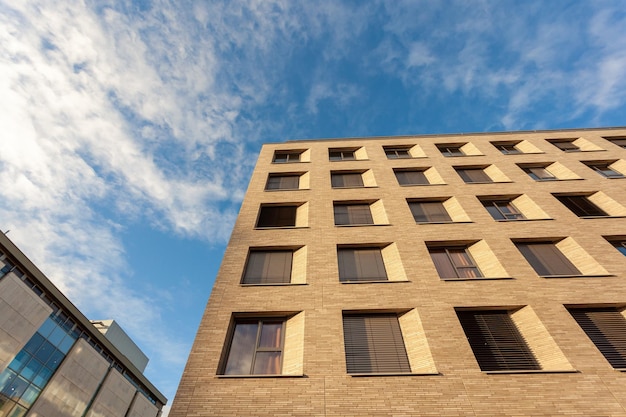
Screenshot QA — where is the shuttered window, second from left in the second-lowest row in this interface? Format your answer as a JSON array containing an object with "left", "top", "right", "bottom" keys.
[{"left": 337, "top": 248, "right": 387, "bottom": 282}]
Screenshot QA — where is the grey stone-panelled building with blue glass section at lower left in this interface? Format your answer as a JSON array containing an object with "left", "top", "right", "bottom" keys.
[{"left": 0, "top": 233, "right": 167, "bottom": 417}]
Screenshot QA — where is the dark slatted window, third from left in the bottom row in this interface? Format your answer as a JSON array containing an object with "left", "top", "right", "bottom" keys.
[{"left": 456, "top": 310, "right": 541, "bottom": 371}]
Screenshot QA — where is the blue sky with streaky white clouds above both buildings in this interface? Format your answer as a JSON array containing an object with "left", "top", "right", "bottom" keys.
[{"left": 0, "top": 0, "right": 626, "bottom": 412}]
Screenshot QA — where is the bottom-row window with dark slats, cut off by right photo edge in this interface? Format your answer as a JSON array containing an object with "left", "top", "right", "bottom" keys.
[{"left": 568, "top": 307, "right": 626, "bottom": 369}]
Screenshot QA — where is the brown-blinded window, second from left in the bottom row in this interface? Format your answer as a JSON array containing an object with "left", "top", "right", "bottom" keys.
[{"left": 343, "top": 314, "right": 411, "bottom": 374}]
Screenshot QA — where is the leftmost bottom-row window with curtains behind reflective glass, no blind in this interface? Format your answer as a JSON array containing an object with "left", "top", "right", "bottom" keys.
[{"left": 223, "top": 317, "right": 285, "bottom": 375}]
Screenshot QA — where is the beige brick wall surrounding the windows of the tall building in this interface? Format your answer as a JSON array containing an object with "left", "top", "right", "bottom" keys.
[{"left": 170, "top": 129, "right": 626, "bottom": 417}]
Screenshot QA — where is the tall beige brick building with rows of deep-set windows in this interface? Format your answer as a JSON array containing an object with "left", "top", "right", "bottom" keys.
[{"left": 170, "top": 128, "right": 626, "bottom": 417}]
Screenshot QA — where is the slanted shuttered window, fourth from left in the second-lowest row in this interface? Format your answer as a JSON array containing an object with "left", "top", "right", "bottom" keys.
[{"left": 515, "top": 242, "right": 581, "bottom": 276}]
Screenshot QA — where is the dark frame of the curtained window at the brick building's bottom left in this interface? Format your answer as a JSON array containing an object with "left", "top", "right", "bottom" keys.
[{"left": 219, "top": 316, "right": 288, "bottom": 376}]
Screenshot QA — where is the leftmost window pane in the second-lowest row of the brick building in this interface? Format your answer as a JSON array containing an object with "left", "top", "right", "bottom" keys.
[{"left": 242, "top": 250, "right": 293, "bottom": 284}]
